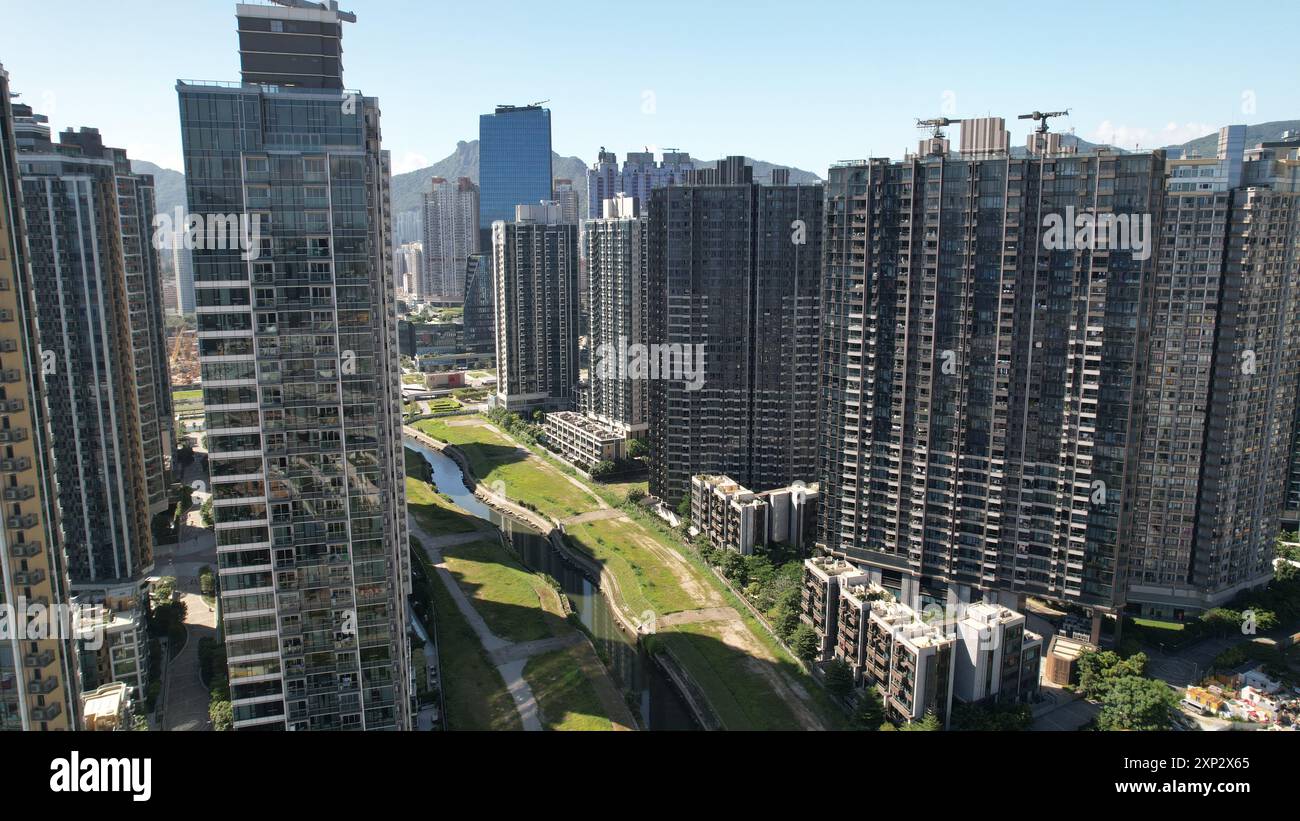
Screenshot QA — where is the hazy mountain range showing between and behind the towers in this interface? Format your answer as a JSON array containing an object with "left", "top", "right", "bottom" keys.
[{"left": 131, "top": 120, "right": 1300, "bottom": 229}]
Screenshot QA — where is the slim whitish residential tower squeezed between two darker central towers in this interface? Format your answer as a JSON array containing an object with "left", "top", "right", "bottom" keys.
[{"left": 582, "top": 195, "right": 649, "bottom": 438}]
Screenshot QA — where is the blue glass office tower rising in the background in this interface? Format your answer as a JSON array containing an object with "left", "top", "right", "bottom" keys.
[{"left": 478, "top": 105, "right": 551, "bottom": 229}]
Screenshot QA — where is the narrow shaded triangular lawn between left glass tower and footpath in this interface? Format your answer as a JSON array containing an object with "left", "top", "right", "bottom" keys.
[{"left": 417, "top": 555, "right": 524, "bottom": 730}]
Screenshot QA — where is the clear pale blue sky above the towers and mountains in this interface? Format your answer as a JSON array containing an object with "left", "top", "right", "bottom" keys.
[{"left": 0, "top": 0, "right": 1300, "bottom": 175}]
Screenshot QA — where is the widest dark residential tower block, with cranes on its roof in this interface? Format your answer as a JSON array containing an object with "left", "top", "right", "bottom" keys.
[{"left": 818, "top": 129, "right": 1164, "bottom": 611}]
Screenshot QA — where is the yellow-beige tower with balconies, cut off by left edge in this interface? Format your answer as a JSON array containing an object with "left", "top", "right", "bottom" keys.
[{"left": 0, "top": 66, "right": 78, "bottom": 730}]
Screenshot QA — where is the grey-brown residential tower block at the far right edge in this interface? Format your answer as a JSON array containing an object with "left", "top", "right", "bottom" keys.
[{"left": 1127, "top": 126, "right": 1300, "bottom": 620}]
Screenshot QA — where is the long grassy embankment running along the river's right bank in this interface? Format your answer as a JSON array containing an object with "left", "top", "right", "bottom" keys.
[{"left": 416, "top": 417, "right": 844, "bottom": 730}]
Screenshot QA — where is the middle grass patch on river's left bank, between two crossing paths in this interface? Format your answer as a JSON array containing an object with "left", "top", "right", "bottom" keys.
[{"left": 442, "top": 540, "right": 573, "bottom": 642}]
